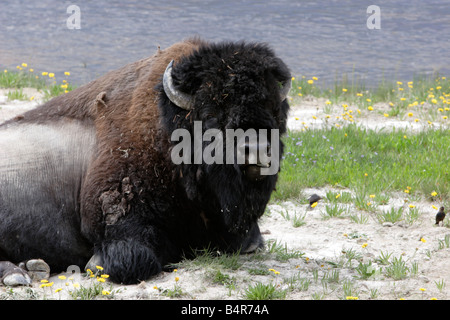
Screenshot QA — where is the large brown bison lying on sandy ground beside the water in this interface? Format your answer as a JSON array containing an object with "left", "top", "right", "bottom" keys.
[{"left": 0, "top": 39, "right": 291, "bottom": 284}]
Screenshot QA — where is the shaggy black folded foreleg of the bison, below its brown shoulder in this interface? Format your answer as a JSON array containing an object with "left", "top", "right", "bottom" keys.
[{"left": 86, "top": 239, "right": 162, "bottom": 284}]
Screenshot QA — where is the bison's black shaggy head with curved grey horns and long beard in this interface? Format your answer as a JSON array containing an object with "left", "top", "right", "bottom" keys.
[{"left": 158, "top": 43, "right": 291, "bottom": 251}]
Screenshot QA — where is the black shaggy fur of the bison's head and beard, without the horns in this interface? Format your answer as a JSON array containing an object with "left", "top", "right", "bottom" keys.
[{"left": 159, "top": 42, "right": 291, "bottom": 245}]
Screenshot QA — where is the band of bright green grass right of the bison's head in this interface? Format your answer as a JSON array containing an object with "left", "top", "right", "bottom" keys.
[{"left": 272, "top": 125, "right": 450, "bottom": 204}]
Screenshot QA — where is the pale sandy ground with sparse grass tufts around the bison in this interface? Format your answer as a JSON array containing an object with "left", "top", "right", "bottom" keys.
[{"left": 0, "top": 89, "right": 450, "bottom": 300}]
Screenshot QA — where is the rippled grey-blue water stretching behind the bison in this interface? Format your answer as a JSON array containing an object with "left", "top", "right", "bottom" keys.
[{"left": 0, "top": 0, "right": 450, "bottom": 86}]
